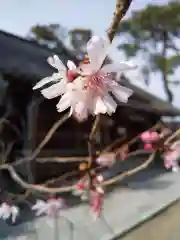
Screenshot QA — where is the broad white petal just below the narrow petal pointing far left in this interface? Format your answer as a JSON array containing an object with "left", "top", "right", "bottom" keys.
[{"left": 41, "top": 79, "right": 66, "bottom": 99}]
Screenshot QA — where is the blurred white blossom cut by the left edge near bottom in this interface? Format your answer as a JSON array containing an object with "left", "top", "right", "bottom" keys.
[{"left": 0, "top": 202, "right": 19, "bottom": 223}]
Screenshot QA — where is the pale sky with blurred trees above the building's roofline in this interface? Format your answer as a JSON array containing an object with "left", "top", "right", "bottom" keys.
[{"left": 0, "top": 0, "right": 180, "bottom": 107}]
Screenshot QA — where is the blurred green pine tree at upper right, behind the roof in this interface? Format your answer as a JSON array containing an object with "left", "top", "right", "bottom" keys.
[{"left": 117, "top": 1, "right": 180, "bottom": 101}]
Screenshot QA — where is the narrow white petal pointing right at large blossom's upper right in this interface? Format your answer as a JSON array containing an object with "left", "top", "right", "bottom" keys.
[{"left": 102, "top": 62, "right": 137, "bottom": 73}]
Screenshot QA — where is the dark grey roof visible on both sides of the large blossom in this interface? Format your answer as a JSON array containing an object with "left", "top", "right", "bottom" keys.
[{"left": 0, "top": 31, "right": 180, "bottom": 115}]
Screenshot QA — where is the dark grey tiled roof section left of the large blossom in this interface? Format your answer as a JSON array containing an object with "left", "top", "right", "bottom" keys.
[{"left": 0, "top": 31, "right": 74, "bottom": 81}]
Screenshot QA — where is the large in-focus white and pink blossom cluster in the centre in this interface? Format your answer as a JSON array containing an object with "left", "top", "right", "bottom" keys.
[{"left": 33, "top": 36, "right": 136, "bottom": 121}]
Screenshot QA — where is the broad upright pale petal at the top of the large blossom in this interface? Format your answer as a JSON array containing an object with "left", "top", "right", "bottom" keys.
[{"left": 87, "top": 36, "right": 110, "bottom": 71}]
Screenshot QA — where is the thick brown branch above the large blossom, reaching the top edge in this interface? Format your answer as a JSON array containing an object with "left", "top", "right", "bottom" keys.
[{"left": 108, "top": 0, "right": 132, "bottom": 42}]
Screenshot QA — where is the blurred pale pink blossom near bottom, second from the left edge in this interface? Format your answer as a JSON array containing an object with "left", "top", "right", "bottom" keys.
[{"left": 32, "top": 198, "right": 65, "bottom": 217}]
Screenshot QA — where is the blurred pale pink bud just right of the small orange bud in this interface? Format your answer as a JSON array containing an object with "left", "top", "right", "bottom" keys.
[{"left": 96, "top": 152, "right": 116, "bottom": 167}]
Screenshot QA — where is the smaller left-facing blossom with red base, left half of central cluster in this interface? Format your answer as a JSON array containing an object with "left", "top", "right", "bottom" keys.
[{"left": 33, "top": 55, "right": 77, "bottom": 99}]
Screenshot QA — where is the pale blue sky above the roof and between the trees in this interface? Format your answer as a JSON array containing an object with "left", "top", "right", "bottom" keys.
[{"left": 0, "top": 0, "right": 180, "bottom": 107}]
